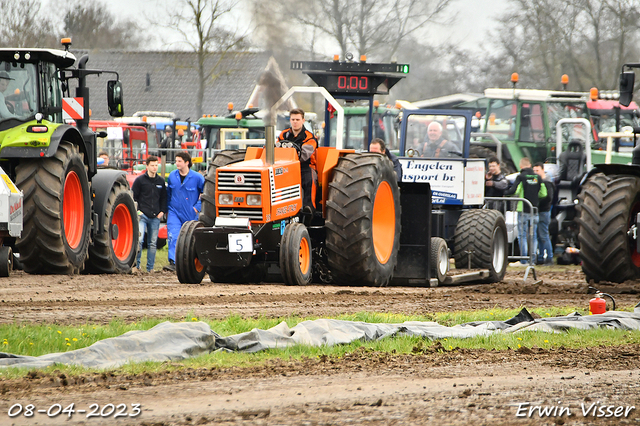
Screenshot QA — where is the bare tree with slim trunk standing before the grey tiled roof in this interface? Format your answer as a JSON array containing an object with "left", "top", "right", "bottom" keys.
[{"left": 164, "top": 0, "right": 247, "bottom": 116}]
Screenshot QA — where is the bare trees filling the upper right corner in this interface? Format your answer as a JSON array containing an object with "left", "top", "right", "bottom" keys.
[{"left": 485, "top": 0, "right": 640, "bottom": 91}]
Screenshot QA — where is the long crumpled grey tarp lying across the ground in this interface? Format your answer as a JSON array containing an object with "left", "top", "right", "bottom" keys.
[{"left": 0, "top": 307, "right": 640, "bottom": 369}]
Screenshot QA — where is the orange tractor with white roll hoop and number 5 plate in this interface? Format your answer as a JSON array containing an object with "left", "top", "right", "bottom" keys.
[{"left": 176, "top": 59, "right": 418, "bottom": 286}]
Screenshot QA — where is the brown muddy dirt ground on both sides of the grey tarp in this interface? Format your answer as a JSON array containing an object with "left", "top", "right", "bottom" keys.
[{"left": 0, "top": 266, "right": 640, "bottom": 425}]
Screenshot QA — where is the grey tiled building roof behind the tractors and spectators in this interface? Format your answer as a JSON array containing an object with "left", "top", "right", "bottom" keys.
[{"left": 71, "top": 50, "right": 284, "bottom": 121}]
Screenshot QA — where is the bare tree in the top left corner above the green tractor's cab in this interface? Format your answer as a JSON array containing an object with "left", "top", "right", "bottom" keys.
[{"left": 0, "top": 0, "right": 59, "bottom": 47}]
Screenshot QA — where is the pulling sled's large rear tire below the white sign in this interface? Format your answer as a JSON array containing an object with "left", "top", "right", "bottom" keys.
[{"left": 453, "top": 209, "right": 509, "bottom": 283}]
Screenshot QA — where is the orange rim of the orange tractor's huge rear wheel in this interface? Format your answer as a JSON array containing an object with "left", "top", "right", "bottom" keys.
[{"left": 371, "top": 181, "right": 396, "bottom": 264}]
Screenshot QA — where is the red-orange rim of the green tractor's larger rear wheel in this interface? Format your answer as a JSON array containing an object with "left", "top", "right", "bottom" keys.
[{"left": 62, "top": 172, "right": 84, "bottom": 249}]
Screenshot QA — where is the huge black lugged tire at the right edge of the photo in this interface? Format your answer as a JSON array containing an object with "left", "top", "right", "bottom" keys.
[{"left": 576, "top": 173, "right": 640, "bottom": 283}]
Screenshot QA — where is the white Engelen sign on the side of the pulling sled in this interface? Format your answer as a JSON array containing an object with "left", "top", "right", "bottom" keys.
[{"left": 400, "top": 158, "right": 484, "bottom": 205}]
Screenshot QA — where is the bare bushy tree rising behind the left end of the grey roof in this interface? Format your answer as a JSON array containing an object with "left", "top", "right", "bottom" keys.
[{"left": 62, "top": 0, "right": 145, "bottom": 49}]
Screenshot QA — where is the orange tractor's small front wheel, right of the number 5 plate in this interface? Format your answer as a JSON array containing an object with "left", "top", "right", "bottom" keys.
[{"left": 280, "top": 223, "right": 313, "bottom": 285}]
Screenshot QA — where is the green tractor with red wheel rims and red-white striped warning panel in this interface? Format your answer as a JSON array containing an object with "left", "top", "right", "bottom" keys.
[{"left": 0, "top": 39, "right": 138, "bottom": 274}]
